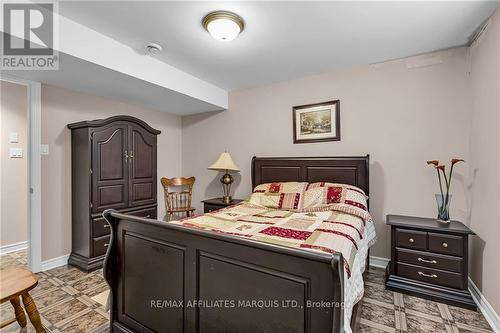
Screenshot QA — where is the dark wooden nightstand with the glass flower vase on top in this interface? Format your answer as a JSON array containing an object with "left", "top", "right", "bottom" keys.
[{"left": 385, "top": 215, "right": 477, "bottom": 309}]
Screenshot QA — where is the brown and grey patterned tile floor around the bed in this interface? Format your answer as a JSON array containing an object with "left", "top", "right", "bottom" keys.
[{"left": 0, "top": 251, "right": 491, "bottom": 333}]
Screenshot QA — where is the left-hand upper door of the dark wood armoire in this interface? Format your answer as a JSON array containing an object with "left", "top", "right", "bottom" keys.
[{"left": 91, "top": 124, "right": 129, "bottom": 212}]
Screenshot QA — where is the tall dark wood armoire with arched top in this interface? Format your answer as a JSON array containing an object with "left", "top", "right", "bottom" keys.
[{"left": 68, "top": 116, "right": 160, "bottom": 271}]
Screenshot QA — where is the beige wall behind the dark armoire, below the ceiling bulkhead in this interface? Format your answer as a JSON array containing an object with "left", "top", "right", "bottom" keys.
[{"left": 42, "top": 85, "right": 181, "bottom": 260}]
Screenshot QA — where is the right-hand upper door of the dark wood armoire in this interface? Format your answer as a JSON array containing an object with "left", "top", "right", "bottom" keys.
[{"left": 129, "top": 124, "right": 157, "bottom": 206}]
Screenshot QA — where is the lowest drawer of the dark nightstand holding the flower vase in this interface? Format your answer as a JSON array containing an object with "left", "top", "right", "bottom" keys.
[{"left": 396, "top": 262, "right": 464, "bottom": 289}]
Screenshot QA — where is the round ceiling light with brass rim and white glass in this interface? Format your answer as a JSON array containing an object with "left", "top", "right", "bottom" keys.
[{"left": 201, "top": 10, "right": 245, "bottom": 42}]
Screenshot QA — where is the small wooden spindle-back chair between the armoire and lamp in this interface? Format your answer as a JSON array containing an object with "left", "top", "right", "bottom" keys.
[{"left": 161, "top": 177, "right": 195, "bottom": 221}]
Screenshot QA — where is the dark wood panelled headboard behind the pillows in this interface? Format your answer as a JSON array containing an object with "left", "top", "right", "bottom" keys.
[{"left": 252, "top": 155, "right": 370, "bottom": 195}]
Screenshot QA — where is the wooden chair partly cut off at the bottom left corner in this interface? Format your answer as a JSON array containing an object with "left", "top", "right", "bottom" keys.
[{"left": 0, "top": 266, "right": 46, "bottom": 333}]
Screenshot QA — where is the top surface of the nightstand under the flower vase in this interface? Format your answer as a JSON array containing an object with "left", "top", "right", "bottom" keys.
[{"left": 386, "top": 215, "right": 475, "bottom": 235}]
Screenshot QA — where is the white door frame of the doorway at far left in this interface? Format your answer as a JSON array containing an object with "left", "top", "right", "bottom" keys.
[{"left": 0, "top": 73, "right": 42, "bottom": 273}]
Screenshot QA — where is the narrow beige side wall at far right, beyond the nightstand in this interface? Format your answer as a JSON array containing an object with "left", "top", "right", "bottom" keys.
[{"left": 470, "top": 9, "right": 500, "bottom": 314}]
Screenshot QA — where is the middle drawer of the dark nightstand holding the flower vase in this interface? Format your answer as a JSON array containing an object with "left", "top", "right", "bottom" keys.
[{"left": 396, "top": 248, "right": 463, "bottom": 273}]
